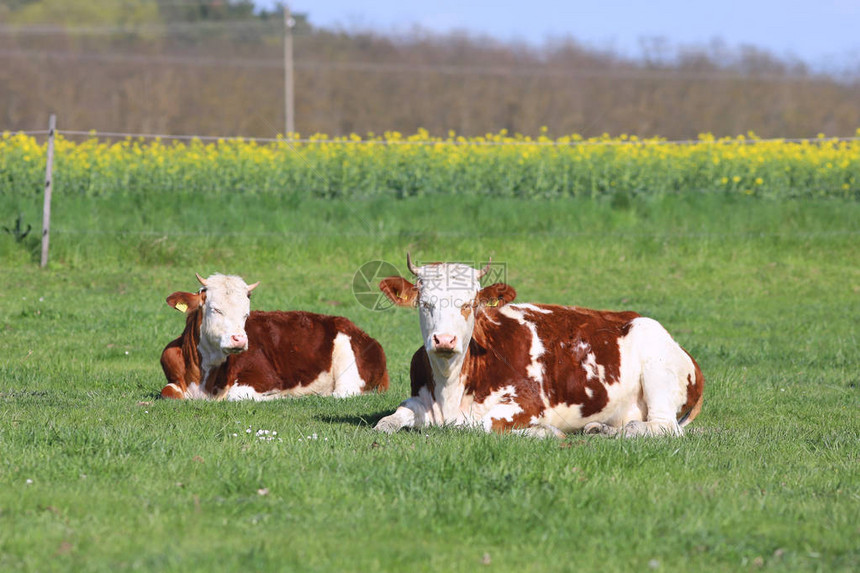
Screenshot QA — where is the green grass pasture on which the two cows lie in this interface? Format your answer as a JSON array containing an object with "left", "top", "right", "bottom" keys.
[{"left": 0, "top": 193, "right": 860, "bottom": 572}]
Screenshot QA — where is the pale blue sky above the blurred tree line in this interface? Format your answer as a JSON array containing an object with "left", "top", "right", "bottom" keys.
[{"left": 266, "top": 0, "right": 860, "bottom": 69}]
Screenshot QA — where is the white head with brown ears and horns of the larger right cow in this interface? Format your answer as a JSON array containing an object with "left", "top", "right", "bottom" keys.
[{"left": 379, "top": 254, "right": 516, "bottom": 366}]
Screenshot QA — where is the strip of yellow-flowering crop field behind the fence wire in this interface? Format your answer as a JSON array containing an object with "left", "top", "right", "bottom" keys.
[{"left": 0, "top": 130, "right": 860, "bottom": 198}]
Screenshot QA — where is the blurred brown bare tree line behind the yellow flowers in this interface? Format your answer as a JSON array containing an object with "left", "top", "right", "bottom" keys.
[{"left": 0, "top": 0, "right": 860, "bottom": 139}]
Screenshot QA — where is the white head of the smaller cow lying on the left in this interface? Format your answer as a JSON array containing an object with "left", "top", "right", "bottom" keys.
[{"left": 197, "top": 274, "right": 260, "bottom": 356}]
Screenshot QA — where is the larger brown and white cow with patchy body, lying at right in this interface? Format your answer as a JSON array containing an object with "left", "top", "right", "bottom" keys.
[{"left": 376, "top": 255, "right": 704, "bottom": 437}]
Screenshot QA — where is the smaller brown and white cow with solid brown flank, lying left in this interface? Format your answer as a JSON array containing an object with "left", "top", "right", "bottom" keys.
[{"left": 161, "top": 274, "right": 388, "bottom": 400}]
